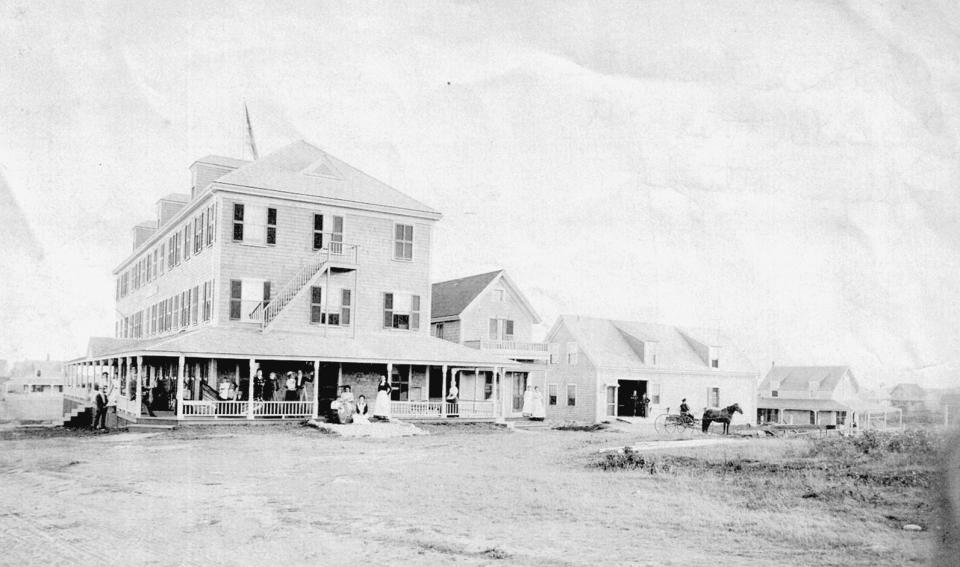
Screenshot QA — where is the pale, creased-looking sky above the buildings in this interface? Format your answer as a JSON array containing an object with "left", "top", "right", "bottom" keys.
[{"left": 0, "top": 0, "right": 960, "bottom": 387}]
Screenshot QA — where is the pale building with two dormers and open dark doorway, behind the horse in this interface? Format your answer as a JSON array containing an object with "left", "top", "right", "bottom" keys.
[{"left": 545, "top": 315, "right": 758, "bottom": 422}]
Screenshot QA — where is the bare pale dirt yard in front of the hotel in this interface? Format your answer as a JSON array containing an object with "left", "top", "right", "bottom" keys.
[{"left": 0, "top": 425, "right": 937, "bottom": 567}]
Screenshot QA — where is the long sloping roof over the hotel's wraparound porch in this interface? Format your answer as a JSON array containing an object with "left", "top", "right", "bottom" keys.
[{"left": 77, "top": 327, "right": 520, "bottom": 367}]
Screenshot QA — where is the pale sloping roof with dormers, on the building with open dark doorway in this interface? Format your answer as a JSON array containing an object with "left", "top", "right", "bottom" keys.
[{"left": 547, "top": 315, "right": 755, "bottom": 373}]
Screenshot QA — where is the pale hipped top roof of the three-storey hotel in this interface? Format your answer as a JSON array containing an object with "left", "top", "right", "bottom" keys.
[{"left": 215, "top": 140, "right": 440, "bottom": 219}]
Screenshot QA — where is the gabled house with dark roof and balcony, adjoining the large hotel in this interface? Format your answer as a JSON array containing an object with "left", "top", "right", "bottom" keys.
[{"left": 431, "top": 270, "right": 549, "bottom": 417}]
